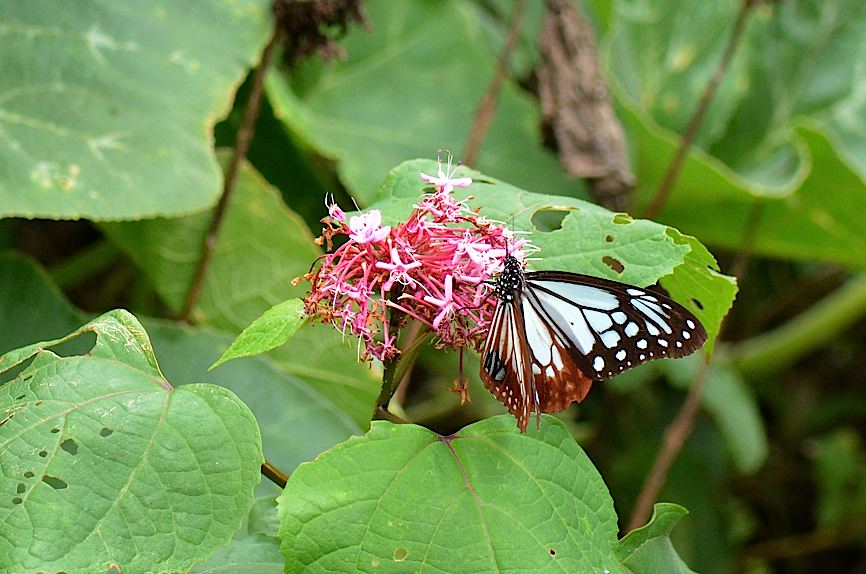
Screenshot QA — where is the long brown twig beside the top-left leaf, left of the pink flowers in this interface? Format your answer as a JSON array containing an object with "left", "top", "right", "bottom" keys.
[{"left": 179, "top": 28, "right": 280, "bottom": 322}]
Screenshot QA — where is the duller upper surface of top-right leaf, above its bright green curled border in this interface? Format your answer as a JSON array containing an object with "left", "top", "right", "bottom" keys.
[{"left": 609, "top": 0, "right": 866, "bottom": 193}]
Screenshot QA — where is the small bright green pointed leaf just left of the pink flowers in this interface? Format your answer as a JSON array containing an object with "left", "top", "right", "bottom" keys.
[{"left": 208, "top": 299, "right": 306, "bottom": 370}]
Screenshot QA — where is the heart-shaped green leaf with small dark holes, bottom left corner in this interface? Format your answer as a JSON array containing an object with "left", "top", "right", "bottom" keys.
[{"left": 0, "top": 311, "right": 262, "bottom": 572}]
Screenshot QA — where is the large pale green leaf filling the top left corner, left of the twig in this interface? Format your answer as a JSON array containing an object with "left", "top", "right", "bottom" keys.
[{"left": 0, "top": 0, "right": 271, "bottom": 220}]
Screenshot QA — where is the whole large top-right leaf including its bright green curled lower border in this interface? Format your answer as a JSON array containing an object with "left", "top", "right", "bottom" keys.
[{"left": 607, "top": 0, "right": 866, "bottom": 269}]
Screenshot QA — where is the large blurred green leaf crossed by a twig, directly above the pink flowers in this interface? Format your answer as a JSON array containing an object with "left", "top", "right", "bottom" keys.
[{"left": 266, "top": 0, "right": 577, "bottom": 204}]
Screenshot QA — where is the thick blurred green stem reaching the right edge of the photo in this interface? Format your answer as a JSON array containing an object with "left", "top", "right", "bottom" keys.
[{"left": 729, "top": 275, "right": 866, "bottom": 376}]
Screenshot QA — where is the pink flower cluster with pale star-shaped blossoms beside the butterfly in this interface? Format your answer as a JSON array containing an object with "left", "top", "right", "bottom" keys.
[{"left": 305, "top": 157, "right": 526, "bottom": 360}]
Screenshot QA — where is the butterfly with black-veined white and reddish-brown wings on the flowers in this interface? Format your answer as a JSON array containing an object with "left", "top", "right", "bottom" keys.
[{"left": 481, "top": 255, "right": 707, "bottom": 432}]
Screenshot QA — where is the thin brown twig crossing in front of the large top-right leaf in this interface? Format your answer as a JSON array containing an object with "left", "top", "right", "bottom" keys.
[{"left": 643, "top": 0, "right": 755, "bottom": 219}]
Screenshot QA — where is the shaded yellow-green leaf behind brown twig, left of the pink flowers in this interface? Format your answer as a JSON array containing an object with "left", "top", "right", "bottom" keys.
[{"left": 102, "top": 158, "right": 378, "bottom": 425}]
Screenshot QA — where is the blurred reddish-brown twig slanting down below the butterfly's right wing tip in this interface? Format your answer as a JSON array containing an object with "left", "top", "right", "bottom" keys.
[{"left": 625, "top": 362, "right": 709, "bottom": 532}]
